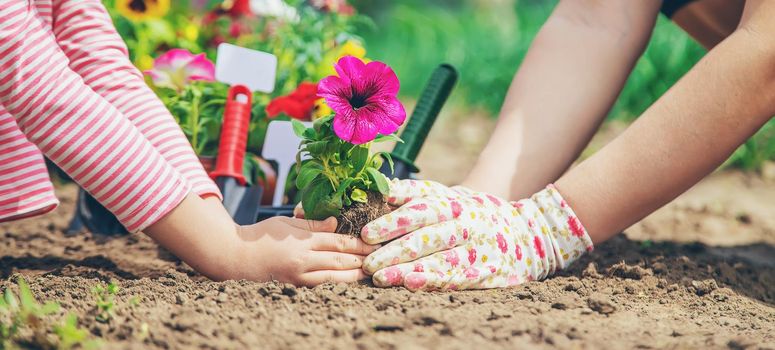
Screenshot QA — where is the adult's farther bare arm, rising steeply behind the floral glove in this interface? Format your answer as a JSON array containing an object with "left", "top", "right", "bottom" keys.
[{"left": 463, "top": 0, "right": 661, "bottom": 199}]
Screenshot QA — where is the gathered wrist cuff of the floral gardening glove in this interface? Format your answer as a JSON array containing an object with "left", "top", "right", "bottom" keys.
[{"left": 530, "top": 184, "right": 594, "bottom": 274}]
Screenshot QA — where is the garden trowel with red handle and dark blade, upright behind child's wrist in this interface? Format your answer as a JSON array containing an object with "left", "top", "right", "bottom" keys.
[{"left": 210, "top": 85, "right": 262, "bottom": 225}]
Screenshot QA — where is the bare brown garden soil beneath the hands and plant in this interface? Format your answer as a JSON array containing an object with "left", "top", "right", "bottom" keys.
[{"left": 0, "top": 172, "right": 775, "bottom": 349}]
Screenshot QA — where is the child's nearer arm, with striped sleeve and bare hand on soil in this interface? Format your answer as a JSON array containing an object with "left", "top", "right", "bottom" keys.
[{"left": 0, "top": 0, "right": 372, "bottom": 285}]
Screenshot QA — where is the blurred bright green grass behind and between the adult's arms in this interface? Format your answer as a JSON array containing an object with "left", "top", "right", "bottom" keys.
[{"left": 353, "top": 0, "right": 775, "bottom": 170}]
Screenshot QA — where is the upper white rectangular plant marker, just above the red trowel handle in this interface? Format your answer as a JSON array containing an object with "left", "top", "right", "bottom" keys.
[{"left": 215, "top": 43, "right": 277, "bottom": 93}]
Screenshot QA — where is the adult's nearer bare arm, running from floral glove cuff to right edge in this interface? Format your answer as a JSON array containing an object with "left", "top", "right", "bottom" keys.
[{"left": 556, "top": 0, "right": 775, "bottom": 242}]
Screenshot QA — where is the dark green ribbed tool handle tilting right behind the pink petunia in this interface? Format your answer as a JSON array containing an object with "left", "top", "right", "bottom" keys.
[{"left": 380, "top": 64, "right": 457, "bottom": 179}]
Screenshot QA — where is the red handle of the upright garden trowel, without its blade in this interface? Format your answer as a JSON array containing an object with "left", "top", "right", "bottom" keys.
[{"left": 210, "top": 85, "right": 253, "bottom": 186}]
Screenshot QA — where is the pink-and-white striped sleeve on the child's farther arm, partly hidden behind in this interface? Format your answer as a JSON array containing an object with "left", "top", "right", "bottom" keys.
[{"left": 51, "top": 0, "right": 221, "bottom": 198}]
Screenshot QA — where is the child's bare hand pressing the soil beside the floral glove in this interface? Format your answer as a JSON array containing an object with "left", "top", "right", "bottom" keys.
[{"left": 232, "top": 217, "right": 376, "bottom": 286}]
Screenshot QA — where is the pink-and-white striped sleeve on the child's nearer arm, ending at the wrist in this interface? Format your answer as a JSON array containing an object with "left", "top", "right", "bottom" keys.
[{"left": 0, "top": 0, "right": 189, "bottom": 231}]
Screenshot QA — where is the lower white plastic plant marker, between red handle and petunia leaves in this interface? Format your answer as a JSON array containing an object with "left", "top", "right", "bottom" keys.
[{"left": 261, "top": 120, "right": 312, "bottom": 206}]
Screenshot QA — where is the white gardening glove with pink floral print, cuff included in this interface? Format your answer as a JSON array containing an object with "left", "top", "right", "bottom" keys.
[{"left": 361, "top": 180, "right": 593, "bottom": 290}]
